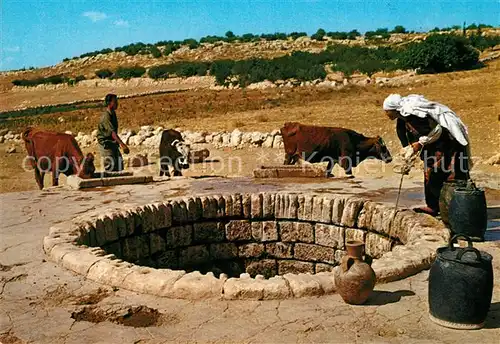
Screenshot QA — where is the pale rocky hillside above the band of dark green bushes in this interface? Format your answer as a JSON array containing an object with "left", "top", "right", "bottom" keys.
[{"left": 0, "top": 28, "right": 500, "bottom": 91}]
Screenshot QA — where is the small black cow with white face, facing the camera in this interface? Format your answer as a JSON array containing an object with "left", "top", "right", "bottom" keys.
[{"left": 160, "top": 129, "right": 190, "bottom": 177}]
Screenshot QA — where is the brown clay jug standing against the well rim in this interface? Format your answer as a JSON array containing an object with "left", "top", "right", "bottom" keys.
[{"left": 335, "top": 241, "right": 376, "bottom": 305}]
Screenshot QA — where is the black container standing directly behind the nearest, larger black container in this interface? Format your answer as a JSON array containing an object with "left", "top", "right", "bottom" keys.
[{"left": 448, "top": 182, "right": 488, "bottom": 241}]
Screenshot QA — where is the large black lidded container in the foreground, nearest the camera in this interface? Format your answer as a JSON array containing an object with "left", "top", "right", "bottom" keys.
[{"left": 429, "top": 235, "right": 493, "bottom": 330}]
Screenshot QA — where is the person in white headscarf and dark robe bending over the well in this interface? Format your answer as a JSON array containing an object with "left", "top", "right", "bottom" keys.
[{"left": 383, "top": 94, "right": 472, "bottom": 216}]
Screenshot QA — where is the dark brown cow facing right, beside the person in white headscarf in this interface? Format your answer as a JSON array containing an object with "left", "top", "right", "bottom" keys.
[{"left": 281, "top": 122, "right": 392, "bottom": 175}]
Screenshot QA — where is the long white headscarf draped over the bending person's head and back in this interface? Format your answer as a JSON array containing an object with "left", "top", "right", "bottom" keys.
[{"left": 383, "top": 94, "right": 469, "bottom": 146}]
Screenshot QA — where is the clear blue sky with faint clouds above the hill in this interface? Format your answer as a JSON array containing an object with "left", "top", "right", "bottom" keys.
[{"left": 0, "top": 0, "right": 500, "bottom": 71}]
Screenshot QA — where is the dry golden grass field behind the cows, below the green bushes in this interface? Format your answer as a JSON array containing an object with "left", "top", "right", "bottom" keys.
[{"left": 0, "top": 61, "right": 500, "bottom": 191}]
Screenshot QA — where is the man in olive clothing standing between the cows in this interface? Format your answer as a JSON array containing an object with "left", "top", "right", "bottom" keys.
[{"left": 97, "top": 94, "right": 129, "bottom": 172}]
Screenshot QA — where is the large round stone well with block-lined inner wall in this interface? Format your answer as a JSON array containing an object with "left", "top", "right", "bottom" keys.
[{"left": 43, "top": 193, "right": 449, "bottom": 300}]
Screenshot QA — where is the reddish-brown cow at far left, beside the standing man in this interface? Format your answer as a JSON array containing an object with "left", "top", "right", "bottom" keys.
[{"left": 22, "top": 127, "right": 95, "bottom": 190}]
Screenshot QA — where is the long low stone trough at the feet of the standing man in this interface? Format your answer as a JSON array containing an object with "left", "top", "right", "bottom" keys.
[{"left": 66, "top": 171, "right": 153, "bottom": 189}]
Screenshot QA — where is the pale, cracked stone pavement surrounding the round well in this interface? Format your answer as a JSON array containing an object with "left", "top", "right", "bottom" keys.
[{"left": 0, "top": 177, "right": 500, "bottom": 344}]
